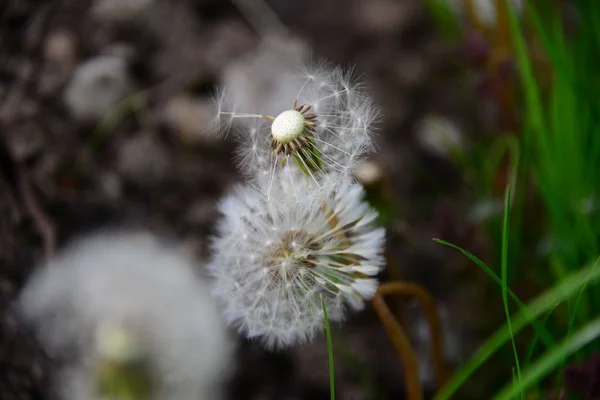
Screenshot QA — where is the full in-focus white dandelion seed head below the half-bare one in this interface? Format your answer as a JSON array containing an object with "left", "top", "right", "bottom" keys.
[{"left": 208, "top": 177, "right": 385, "bottom": 348}]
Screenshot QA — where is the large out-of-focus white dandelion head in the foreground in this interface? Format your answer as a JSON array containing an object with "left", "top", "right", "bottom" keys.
[{"left": 18, "top": 232, "right": 233, "bottom": 400}]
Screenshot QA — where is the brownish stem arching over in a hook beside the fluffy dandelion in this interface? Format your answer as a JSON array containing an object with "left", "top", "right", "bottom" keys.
[{"left": 378, "top": 281, "right": 450, "bottom": 389}]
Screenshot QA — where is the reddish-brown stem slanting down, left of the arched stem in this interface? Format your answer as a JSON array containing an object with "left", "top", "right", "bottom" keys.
[{"left": 371, "top": 292, "right": 423, "bottom": 400}]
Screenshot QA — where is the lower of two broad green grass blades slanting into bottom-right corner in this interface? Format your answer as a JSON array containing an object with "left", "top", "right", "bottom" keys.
[{"left": 494, "top": 318, "right": 600, "bottom": 400}]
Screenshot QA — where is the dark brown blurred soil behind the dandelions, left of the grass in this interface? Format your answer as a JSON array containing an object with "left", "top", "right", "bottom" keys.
[{"left": 0, "top": 0, "right": 508, "bottom": 400}]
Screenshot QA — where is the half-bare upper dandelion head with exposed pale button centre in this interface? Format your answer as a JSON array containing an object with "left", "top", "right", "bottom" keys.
[{"left": 216, "top": 65, "right": 378, "bottom": 194}]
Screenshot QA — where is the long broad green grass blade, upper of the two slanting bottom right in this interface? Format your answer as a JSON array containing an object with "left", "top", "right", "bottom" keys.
[{"left": 434, "top": 258, "right": 600, "bottom": 400}]
